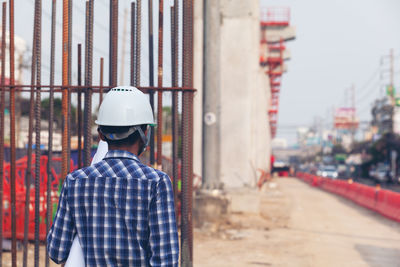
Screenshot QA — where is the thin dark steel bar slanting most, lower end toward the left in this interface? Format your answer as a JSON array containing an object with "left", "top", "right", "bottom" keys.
[{"left": 23, "top": 0, "right": 37, "bottom": 267}]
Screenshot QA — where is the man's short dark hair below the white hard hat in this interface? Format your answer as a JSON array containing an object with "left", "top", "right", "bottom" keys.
[{"left": 99, "top": 124, "right": 147, "bottom": 146}]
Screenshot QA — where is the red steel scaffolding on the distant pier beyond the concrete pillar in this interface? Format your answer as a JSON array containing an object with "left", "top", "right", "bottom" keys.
[{"left": 260, "top": 7, "right": 290, "bottom": 138}]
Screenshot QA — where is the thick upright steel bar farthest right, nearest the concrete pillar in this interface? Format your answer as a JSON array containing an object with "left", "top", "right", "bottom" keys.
[{"left": 181, "top": 0, "right": 193, "bottom": 267}]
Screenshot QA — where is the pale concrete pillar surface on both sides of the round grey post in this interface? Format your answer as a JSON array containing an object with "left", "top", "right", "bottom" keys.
[{"left": 194, "top": 0, "right": 271, "bottom": 188}]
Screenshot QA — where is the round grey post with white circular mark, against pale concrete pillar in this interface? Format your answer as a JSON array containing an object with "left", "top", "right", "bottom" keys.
[{"left": 202, "top": 0, "right": 221, "bottom": 189}]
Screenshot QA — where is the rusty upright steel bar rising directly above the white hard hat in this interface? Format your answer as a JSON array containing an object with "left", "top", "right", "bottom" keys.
[{"left": 109, "top": 0, "right": 118, "bottom": 86}]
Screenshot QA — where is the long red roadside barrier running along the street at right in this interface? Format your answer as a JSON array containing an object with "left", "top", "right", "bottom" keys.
[{"left": 297, "top": 172, "right": 400, "bottom": 222}]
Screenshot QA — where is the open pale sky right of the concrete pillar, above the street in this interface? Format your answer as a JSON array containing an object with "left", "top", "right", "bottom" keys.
[{"left": 261, "top": 0, "right": 400, "bottom": 146}]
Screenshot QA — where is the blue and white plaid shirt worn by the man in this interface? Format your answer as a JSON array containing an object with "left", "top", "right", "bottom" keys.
[{"left": 47, "top": 150, "right": 179, "bottom": 266}]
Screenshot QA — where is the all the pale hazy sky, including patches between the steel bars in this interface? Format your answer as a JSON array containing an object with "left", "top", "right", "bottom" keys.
[{"left": 7, "top": 0, "right": 400, "bottom": 146}]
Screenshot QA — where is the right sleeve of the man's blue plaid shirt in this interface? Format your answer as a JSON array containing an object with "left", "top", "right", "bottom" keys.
[{"left": 149, "top": 175, "right": 179, "bottom": 266}]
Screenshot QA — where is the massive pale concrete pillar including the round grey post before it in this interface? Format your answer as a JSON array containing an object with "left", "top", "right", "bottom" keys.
[{"left": 193, "top": 0, "right": 271, "bottom": 189}]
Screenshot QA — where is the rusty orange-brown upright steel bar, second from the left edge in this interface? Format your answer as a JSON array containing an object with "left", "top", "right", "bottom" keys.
[{"left": 9, "top": 0, "right": 17, "bottom": 267}]
